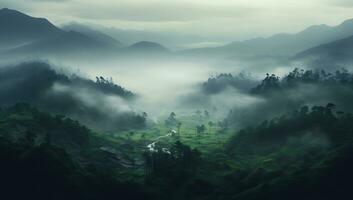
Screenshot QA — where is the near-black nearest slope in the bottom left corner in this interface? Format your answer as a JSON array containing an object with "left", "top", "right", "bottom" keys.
[{"left": 0, "top": 138, "right": 148, "bottom": 200}]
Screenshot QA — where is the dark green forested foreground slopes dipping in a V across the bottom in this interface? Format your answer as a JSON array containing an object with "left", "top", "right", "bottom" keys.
[{"left": 0, "top": 103, "right": 353, "bottom": 199}]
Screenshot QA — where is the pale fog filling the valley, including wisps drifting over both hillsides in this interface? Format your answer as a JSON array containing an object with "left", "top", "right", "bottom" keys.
[{"left": 1, "top": 52, "right": 348, "bottom": 132}]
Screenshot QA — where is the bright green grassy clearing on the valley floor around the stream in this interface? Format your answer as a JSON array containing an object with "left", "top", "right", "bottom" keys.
[{"left": 105, "top": 112, "right": 232, "bottom": 156}]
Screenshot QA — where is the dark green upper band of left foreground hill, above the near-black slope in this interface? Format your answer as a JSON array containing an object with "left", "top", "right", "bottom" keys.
[{"left": 0, "top": 104, "right": 140, "bottom": 170}]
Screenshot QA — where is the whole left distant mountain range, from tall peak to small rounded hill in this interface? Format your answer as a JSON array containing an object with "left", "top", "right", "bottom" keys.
[{"left": 0, "top": 8, "right": 169, "bottom": 59}]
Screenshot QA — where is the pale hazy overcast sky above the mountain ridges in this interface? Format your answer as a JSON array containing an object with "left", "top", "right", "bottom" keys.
[{"left": 0, "top": 0, "right": 353, "bottom": 40}]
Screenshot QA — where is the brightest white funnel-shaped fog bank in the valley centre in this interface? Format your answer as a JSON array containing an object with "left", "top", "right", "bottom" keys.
[{"left": 49, "top": 57, "right": 291, "bottom": 116}]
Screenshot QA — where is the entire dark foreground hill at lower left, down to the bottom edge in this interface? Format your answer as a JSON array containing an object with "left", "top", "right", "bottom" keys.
[{"left": 0, "top": 104, "right": 146, "bottom": 200}]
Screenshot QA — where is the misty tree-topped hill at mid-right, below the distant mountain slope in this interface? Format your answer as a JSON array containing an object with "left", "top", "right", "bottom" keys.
[{"left": 227, "top": 69, "right": 353, "bottom": 128}]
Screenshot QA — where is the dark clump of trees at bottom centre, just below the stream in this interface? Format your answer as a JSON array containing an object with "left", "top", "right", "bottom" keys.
[{"left": 144, "top": 141, "right": 201, "bottom": 199}]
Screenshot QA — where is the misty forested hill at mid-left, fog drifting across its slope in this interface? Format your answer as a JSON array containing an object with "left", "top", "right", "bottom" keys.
[{"left": 0, "top": 62, "right": 145, "bottom": 131}]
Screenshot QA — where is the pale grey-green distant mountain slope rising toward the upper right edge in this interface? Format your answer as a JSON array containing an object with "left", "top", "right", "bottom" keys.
[{"left": 184, "top": 19, "right": 353, "bottom": 57}]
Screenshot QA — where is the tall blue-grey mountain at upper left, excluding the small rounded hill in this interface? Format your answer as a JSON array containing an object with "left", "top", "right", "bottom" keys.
[{"left": 0, "top": 8, "right": 119, "bottom": 56}]
